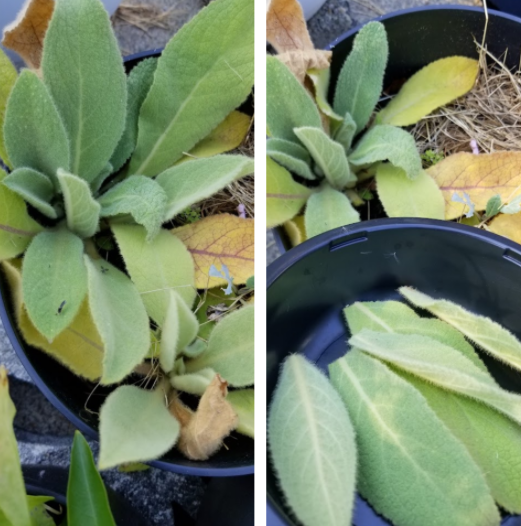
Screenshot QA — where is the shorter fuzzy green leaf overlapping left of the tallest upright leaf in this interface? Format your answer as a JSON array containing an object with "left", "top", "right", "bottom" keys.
[{"left": 4, "top": 69, "right": 68, "bottom": 180}]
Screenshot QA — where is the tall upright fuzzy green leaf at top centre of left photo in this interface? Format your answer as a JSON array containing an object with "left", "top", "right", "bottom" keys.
[{"left": 42, "top": 0, "right": 127, "bottom": 183}]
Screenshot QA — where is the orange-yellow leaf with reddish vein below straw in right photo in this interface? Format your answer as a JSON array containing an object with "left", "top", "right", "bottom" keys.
[{"left": 427, "top": 152, "right": 521, "bottom": 219}]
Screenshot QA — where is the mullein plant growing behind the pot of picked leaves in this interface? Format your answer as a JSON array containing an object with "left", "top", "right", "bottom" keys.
[{"left": 267, "top": 0, "right": 479, "bottom": 243}]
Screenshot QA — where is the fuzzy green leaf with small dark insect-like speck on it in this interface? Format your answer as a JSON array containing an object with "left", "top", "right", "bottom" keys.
[{"left": 22, "top": 228, "right": 87, "bottom": 342}]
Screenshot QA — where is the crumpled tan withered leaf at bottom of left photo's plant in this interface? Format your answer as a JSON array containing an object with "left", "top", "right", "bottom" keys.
[{"left": 170, "top": 374, "right": 239, "bottom": 460}]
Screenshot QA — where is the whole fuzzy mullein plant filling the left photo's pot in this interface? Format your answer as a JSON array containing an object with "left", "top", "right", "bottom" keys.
[{"left": 0, "top": 0, "right": 254, "bottom": 468}]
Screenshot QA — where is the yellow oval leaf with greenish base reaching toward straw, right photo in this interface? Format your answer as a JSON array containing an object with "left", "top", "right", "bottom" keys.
[{"left": 377, "top": 57, "right": 479, "bottom": 126}]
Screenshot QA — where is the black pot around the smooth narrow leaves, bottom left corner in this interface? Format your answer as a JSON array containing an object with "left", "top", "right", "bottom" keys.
[{"left": 22, "top": 466, "right": 147, "bottom": 526}]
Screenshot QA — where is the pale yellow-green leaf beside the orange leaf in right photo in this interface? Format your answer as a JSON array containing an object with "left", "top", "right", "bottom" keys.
[{"left": 376, "top": 163, "right": 445, "bottom": 219}]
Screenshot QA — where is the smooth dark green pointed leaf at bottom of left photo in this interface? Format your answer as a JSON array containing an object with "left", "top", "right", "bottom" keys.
[{"left": 67, "top": 431, "right": 116, "bottom": 526}]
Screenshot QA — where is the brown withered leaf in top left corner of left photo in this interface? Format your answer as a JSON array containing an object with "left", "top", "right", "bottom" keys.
[{"left": 2, "top": 0, "right": 54, "bottom": 69}]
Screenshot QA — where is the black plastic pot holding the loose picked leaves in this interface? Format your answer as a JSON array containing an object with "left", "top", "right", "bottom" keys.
[{"left": 267, "top": 219, "right": 521, "bottom": 526}]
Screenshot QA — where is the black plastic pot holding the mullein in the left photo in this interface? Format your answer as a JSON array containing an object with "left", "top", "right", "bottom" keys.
[{"left": 0, "top": 49, "right": 254, "bottom": 477}]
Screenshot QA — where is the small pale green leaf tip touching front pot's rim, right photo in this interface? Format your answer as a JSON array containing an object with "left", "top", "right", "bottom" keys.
[{"left": 304, "top": 185, "right": 360, "bottom": 239}]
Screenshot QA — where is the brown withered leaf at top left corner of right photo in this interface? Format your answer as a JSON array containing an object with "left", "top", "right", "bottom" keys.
[{"left": 266, "top": 0, "right": 315, "bottom": 53}]
